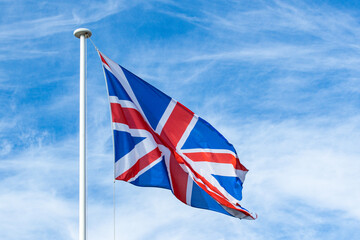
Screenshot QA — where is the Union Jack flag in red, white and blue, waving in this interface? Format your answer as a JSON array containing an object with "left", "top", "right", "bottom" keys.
[{"left": 98, "top": 51, "right": 257, "bottom": 219}]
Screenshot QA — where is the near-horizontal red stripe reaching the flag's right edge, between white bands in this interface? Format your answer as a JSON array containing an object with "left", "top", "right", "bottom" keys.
[{"left": 184, "top": 152, "right": 248, "bottom": 171}]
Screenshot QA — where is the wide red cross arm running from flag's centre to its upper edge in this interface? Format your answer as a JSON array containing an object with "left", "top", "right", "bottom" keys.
[{"left": 160, "top": 103, "right": 194, "bottom": 149}]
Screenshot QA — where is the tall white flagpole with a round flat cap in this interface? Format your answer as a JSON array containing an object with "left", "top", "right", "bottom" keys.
[{"left": 74, "top": 28, "right": 91, "bottom": 240}]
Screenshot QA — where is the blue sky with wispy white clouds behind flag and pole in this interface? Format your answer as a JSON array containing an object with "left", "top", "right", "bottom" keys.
[{"left": 0, "top": 0, "right": 360, "bottom": 240}]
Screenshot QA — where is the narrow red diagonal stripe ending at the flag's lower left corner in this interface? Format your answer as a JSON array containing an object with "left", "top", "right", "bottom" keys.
[{"left": 116, "top": 148, "right": 161, "bottom": 181}]
